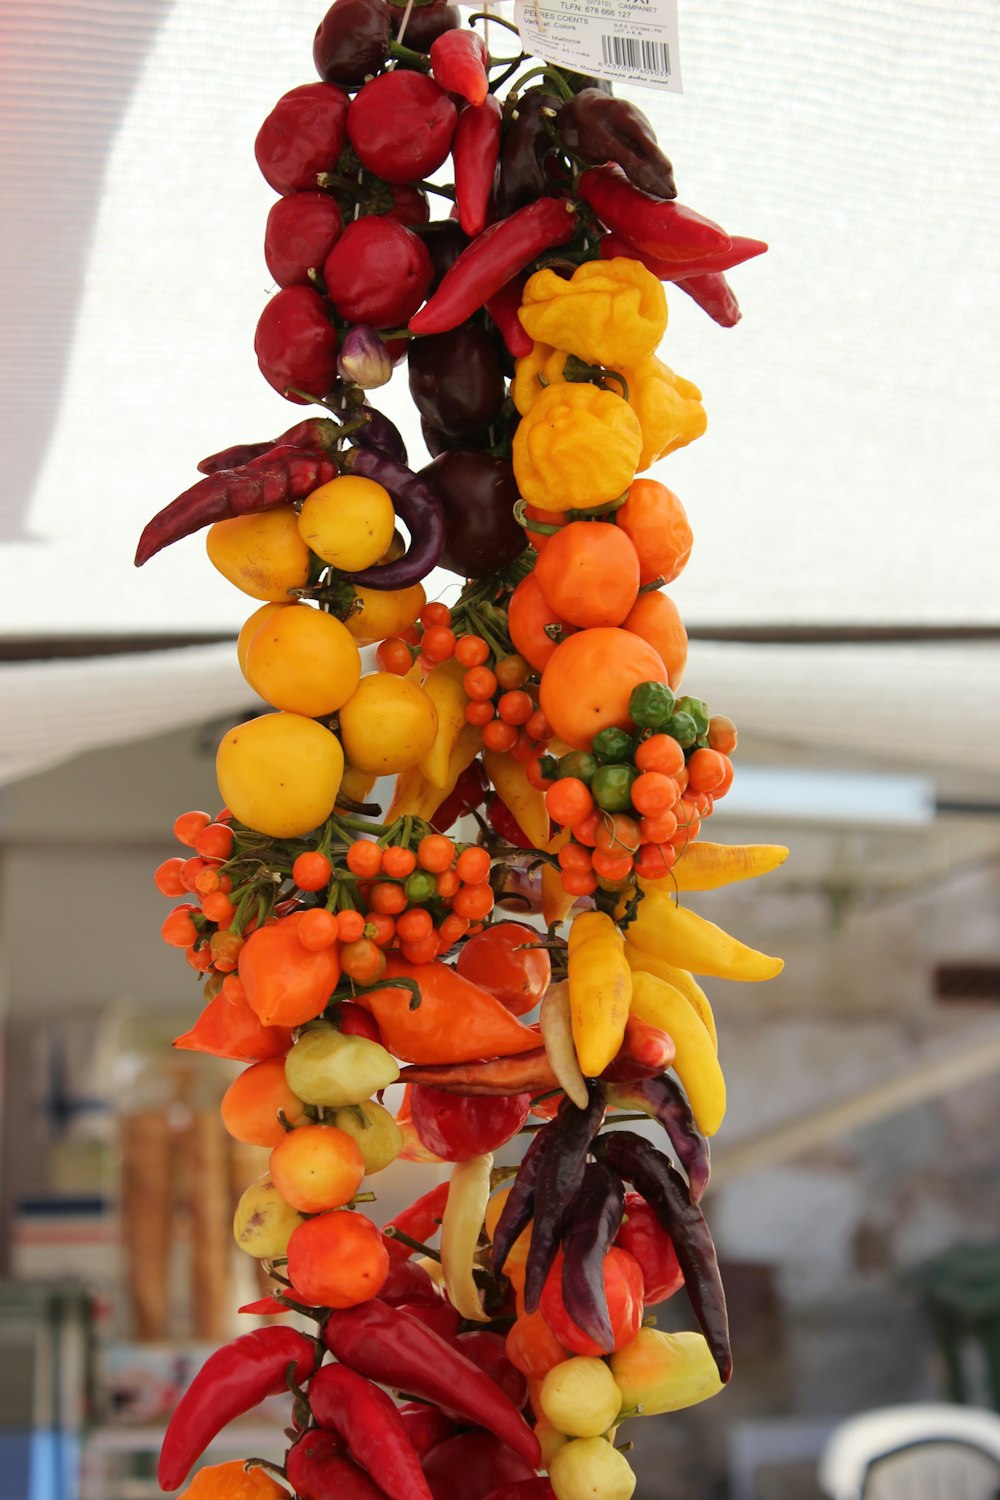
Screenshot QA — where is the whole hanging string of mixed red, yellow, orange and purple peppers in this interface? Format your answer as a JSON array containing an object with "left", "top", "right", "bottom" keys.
[{"left": 136, "top": 0, "right": 786, "bottom": 1500}]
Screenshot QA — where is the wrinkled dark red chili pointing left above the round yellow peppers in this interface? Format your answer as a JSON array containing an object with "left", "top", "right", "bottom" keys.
[{"left": 135, "top": 447, "right": 337, "bottom": 567}]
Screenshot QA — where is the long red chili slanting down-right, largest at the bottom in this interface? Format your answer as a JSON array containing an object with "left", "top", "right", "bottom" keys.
[{"left": 322, "top": 1298, "right": 541, "bottom": 1469}]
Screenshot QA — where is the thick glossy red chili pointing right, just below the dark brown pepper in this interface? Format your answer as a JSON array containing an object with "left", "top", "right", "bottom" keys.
[{"left": 577, "top": 164, "right": 733, "bottom": 266}]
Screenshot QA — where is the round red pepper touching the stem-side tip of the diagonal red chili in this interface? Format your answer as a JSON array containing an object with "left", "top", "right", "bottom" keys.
[{"left": 322, "top": 215, "right": 433, "bottom": 329}]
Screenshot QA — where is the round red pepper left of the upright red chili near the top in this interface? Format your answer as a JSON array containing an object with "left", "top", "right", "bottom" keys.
[{"left": 348, "top": 69, "right": 457, "bottom": 183}]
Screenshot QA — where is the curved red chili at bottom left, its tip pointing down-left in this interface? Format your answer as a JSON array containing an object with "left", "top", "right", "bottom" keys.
[{"left": 157, "top": 1328, "right": 316, "bottom": 1491}]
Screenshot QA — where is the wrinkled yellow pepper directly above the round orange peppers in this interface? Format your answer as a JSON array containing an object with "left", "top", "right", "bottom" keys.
[{"left": 513, "top": 384, "right": 642, "bottom": 512}]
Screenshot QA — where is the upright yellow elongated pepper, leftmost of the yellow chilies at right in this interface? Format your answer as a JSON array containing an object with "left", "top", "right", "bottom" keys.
[{"left": 568, "top": 912, "right": 633, "bottom": 1079}]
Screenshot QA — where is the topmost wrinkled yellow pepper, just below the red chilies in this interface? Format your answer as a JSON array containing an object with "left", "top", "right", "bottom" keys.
[{"left": 519, "top": 257, "right": 667, "bottom": 365}]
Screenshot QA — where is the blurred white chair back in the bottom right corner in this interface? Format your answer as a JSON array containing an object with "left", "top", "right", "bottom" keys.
[{"left": 819, "top": 1404, "right": 1000, "bottom": 1500}]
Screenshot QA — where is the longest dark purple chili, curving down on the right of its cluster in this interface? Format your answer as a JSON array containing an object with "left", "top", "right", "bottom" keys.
[{"left": 594, "top": 1130, "right": 733, "bottom": 1382}]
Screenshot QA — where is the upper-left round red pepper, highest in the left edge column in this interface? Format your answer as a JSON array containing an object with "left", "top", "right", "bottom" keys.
[{"left": 253, "top": 84, "right": 351, "bottom": 195}]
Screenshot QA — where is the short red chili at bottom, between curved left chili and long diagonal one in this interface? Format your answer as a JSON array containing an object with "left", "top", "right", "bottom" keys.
[{"left": 309, "top": 1365, "right": 432, "bottom": 1500}]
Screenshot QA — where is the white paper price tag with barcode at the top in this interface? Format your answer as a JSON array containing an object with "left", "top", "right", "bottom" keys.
[{"left": 514, "top": 0, "right": 682, "bottom": 93}]
